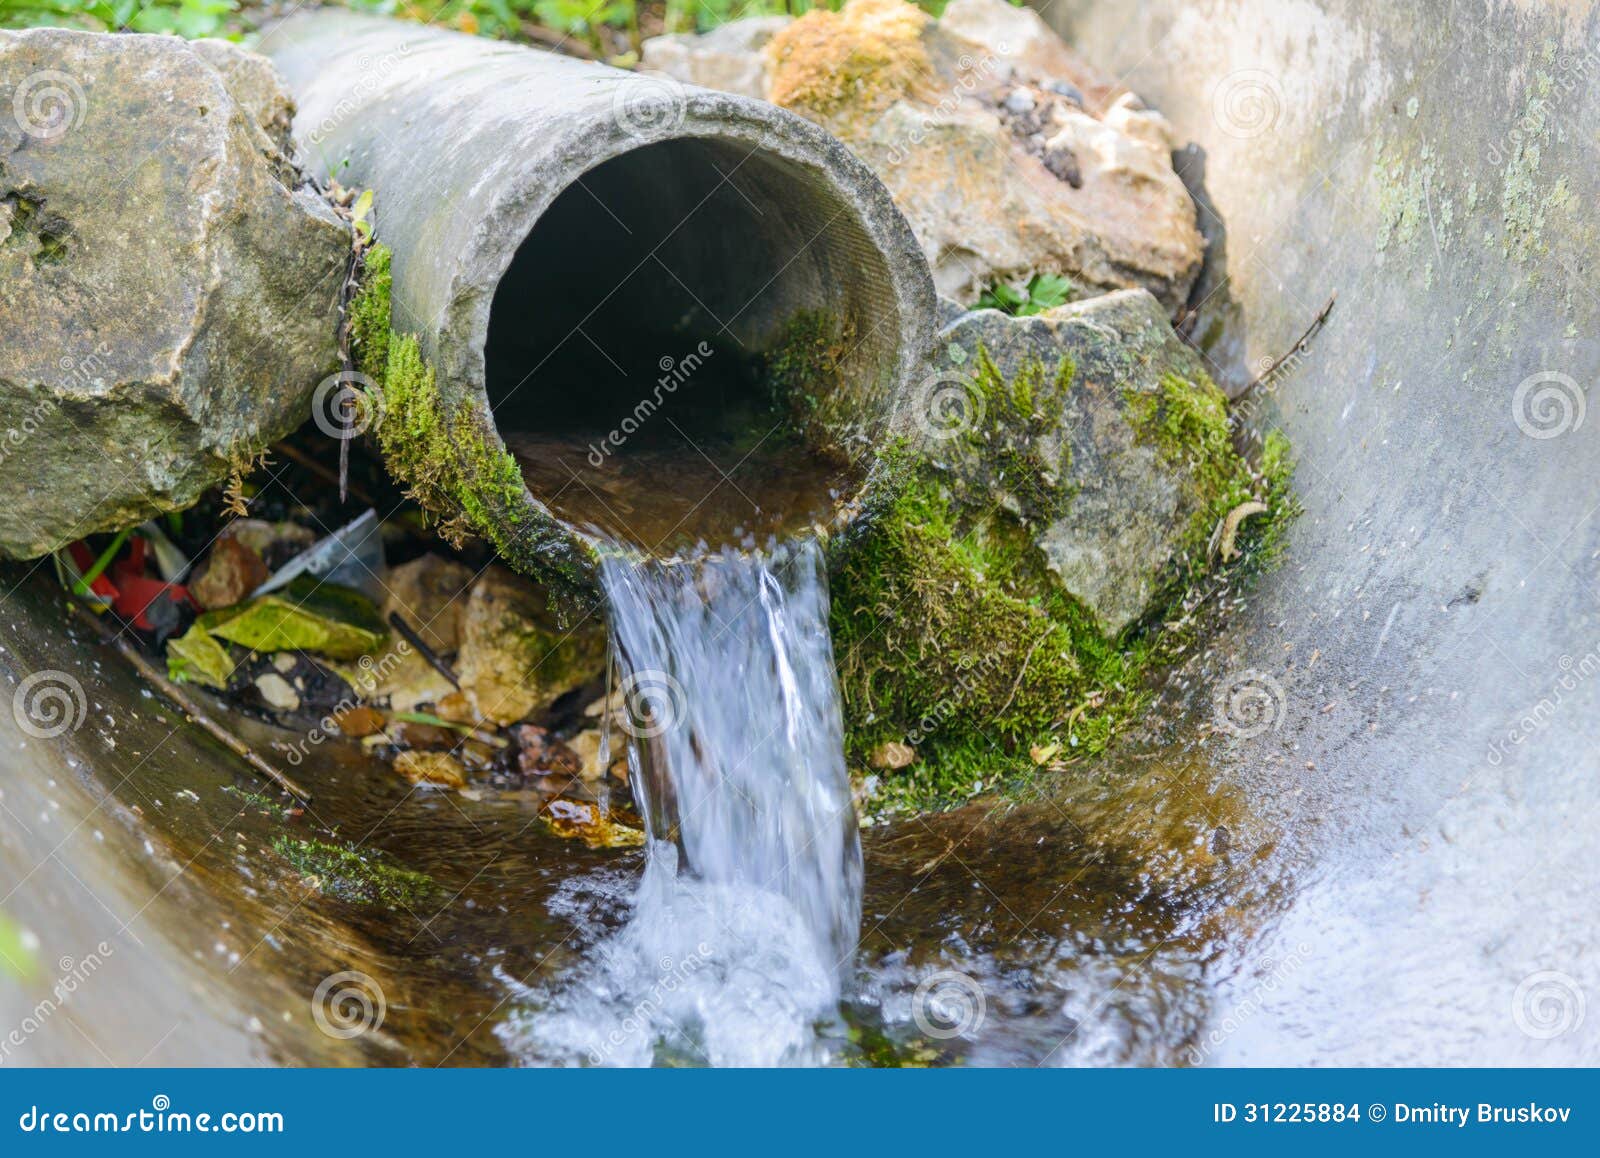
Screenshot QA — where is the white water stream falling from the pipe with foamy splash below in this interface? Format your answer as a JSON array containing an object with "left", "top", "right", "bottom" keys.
[{"left": 506, "top": 541, "right": 861, "bottom": 1065}]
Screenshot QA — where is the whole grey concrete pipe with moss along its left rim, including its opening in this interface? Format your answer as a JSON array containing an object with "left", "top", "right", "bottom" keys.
[{"left": 261, "top": 11, "right": 934, "bottom": 593}]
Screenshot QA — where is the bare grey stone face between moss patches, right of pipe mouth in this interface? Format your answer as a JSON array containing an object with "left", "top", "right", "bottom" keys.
[{"left": 910, "top": 290, "right": 1202, "bottom": 637}]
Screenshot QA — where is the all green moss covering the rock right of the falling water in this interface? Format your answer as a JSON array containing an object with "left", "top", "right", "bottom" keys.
[{"left": 830, "top": 349, "right": 1293, "bottom": 811}]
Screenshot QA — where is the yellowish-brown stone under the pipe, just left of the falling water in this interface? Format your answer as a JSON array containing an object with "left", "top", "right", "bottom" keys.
[{"left": 456, "top": 565, "right": 605, "bottom": 725}]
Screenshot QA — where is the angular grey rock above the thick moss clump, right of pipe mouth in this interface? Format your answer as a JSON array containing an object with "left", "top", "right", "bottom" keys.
[{"left": 907, "top": 290, "right": 1234, "bottom": 637}]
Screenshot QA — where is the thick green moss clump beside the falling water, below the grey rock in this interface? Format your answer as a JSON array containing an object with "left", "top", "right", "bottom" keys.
[{"left": 832, "top": 449, "right": 1146, "bottom": 809}]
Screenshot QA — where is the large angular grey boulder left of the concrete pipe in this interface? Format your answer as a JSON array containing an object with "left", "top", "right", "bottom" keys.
[{"left": 0, "top": 29, "right": 350, "bottom": 557}]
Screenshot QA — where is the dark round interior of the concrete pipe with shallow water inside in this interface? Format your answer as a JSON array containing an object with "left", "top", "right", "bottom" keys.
[{"left": 485, "top": 138, "right": 899, "bottom": 555}]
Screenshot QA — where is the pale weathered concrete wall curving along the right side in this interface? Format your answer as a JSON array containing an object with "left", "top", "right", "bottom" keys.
[{"left": 1048, "top": 0, "right": 1600, "bottom": 1064}]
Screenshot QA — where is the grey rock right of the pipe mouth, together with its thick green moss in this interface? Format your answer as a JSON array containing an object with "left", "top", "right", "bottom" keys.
[{"left": 829, "top": 290, "right": 1288, "bottom": 777}]
